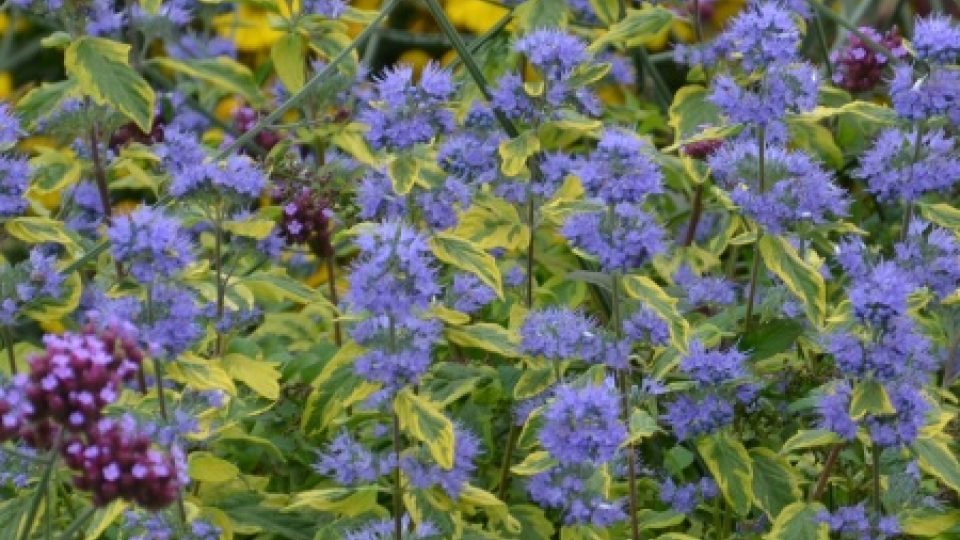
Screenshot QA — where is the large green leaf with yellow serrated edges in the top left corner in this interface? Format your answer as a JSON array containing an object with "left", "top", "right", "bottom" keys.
[{"left": 63, "top": 36, "right": 156, "bottom": 133}]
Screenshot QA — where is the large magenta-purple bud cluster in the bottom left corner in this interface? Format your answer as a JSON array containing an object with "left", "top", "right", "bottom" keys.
[{"left": 0, "top": 325, "right": 185, "bottom": 509}]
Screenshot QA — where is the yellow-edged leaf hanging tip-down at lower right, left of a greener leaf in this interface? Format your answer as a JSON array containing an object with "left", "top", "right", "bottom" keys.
[{"left": 697, "top": 433, "right": 754, "bottom": 516}]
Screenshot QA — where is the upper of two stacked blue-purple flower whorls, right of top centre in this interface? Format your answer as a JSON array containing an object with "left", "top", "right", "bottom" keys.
[{"left": 576, "top": 129, "right": 663, "bottom": 204}]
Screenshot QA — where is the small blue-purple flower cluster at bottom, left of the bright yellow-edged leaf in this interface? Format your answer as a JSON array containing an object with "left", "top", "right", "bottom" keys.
[{"left": 313, "top": 431, "right": 396, "bottom": 486}]
